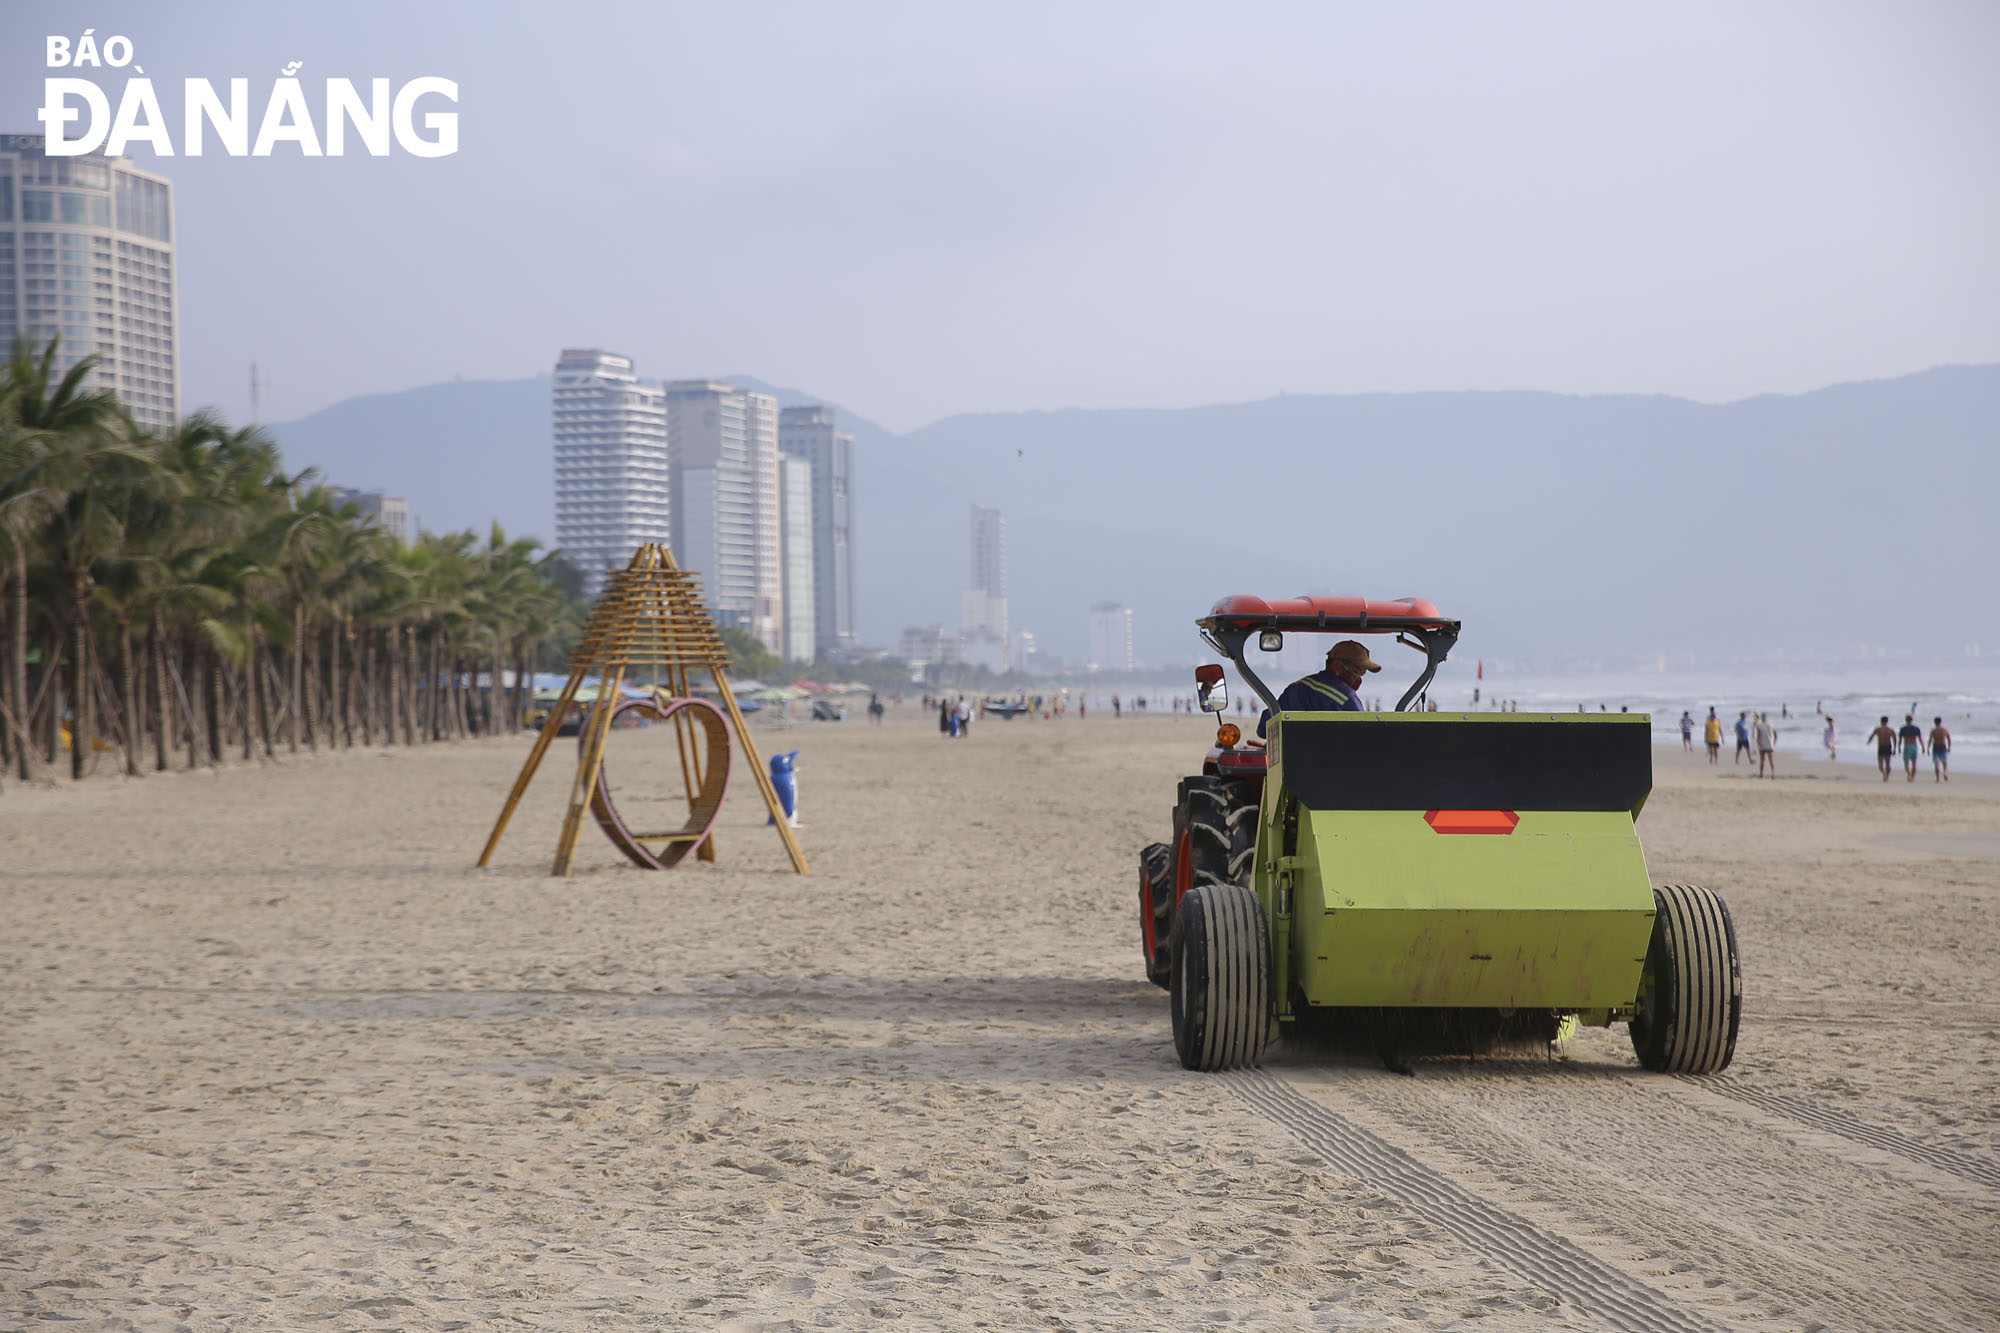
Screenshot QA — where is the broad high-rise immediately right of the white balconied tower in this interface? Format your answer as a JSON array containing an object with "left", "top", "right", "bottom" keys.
[{"left": 666, "top": 380, "right": 784, "bottom": 652}]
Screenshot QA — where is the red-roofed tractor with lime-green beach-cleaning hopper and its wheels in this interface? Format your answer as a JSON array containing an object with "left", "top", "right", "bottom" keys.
[{"left": 1140, "top": 596, "right": 1742, "bottom": 1073}]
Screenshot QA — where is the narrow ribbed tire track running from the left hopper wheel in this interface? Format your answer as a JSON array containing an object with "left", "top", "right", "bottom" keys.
[{"left": 1222, "top": 1071, "right": 1722, "bottom": 1333}]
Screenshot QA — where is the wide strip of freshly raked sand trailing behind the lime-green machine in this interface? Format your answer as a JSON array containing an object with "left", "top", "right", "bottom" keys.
[{"left": 1312, "top": 1061, "right": 2000, "bottom": 1329}]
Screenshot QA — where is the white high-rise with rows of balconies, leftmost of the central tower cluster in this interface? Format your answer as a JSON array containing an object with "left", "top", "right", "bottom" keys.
[{"left": 552, "top": 348, "right": 672, "bottom": 596}]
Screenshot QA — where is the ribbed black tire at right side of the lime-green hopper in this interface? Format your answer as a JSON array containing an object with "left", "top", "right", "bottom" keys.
[{"left": 1630, "top": 885, "right": 1744, "bottom": 1073}]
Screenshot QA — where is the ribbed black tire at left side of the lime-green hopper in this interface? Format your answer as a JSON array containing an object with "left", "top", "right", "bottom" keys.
[{"left": 1170, "top": 885, "right": 1270, "bottom": 1071}]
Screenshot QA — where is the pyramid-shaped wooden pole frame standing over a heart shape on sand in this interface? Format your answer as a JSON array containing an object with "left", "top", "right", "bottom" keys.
[{"left": 480, "top": 542, "right": 810, "bottom": 877}]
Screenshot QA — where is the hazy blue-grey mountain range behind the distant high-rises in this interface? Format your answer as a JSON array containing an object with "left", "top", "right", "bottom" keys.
[{"left": 270, "top": 366, "right": 2000, "bottom": 667}]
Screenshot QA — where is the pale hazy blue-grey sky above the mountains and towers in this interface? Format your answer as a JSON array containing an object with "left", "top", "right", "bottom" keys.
[{"left": 0, "top": 0, "right": 2000, "bottom": 430}]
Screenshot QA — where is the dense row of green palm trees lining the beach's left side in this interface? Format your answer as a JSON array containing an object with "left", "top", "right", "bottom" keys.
[{"left": 0, "top": 340, "right": 584, "bottom": 777}]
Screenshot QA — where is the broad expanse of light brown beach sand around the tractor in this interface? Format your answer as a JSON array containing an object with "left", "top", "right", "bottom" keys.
[{"left": 0, "top": 705, "right": 2000, "bottom": 1331}]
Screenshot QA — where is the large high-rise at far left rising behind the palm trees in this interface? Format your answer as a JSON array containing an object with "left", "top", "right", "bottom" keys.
[{"left": 0, "top": 134, "right": 180, "bottom": 430}]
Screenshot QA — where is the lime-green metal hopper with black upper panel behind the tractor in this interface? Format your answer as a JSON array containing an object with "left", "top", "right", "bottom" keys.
[{"left": 1254, "top": 713, "right": 1654, "bottom": 1021}]
